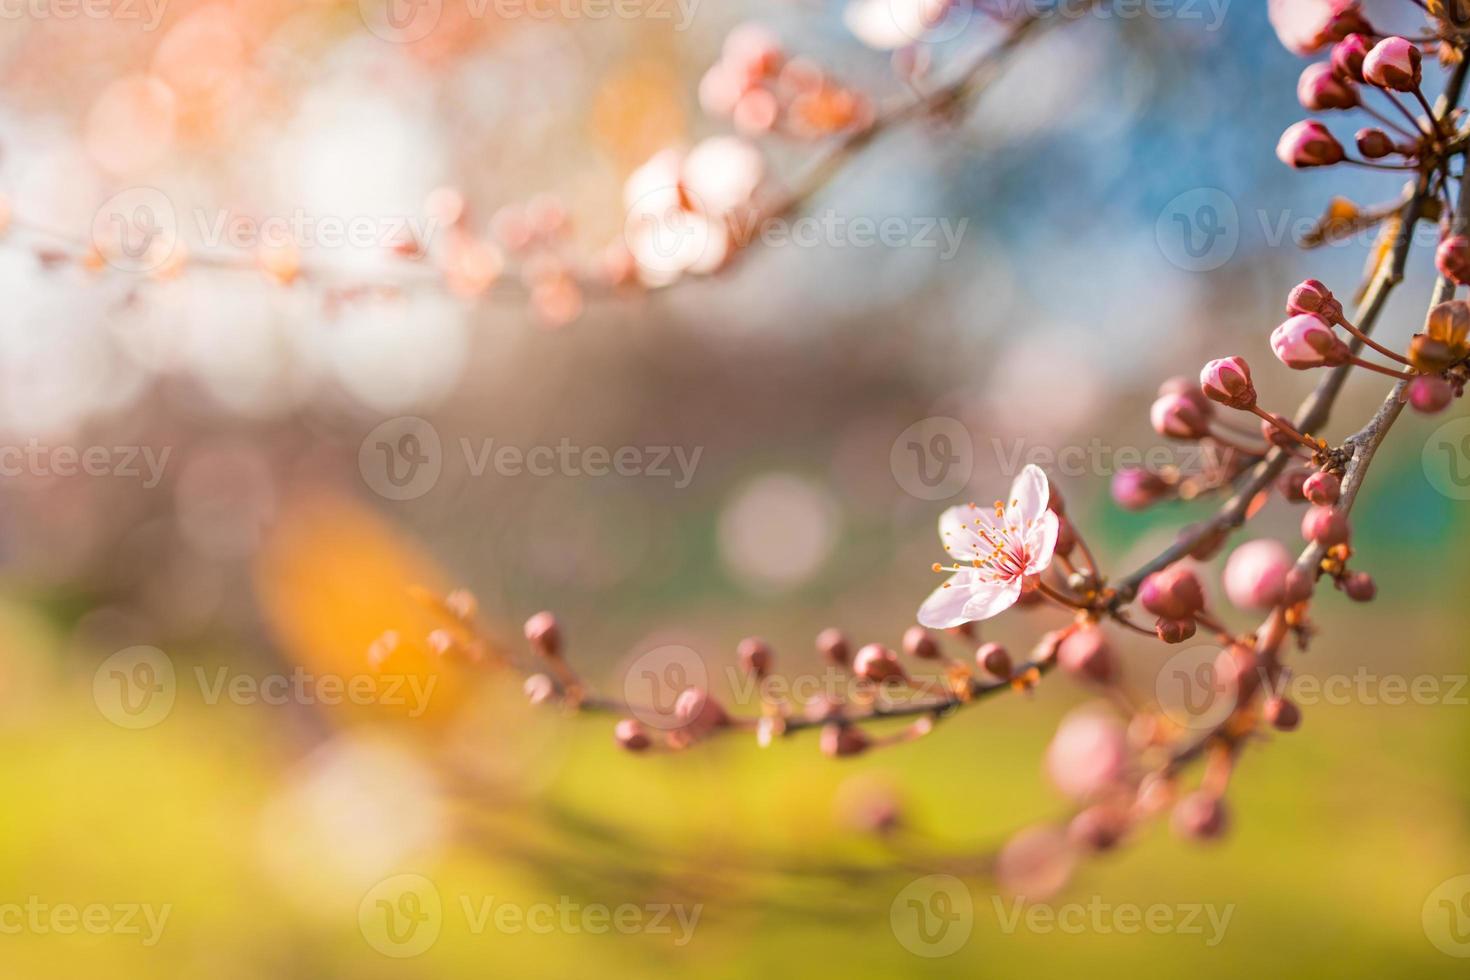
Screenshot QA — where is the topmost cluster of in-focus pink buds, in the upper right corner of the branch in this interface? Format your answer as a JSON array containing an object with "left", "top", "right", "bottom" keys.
[{"left": 1276, "top": 31, "right": 1445, "bottom": 169}]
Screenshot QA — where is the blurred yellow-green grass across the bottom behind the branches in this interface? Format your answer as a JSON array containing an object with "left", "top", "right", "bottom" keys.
[{"left": 0, "top": 599, "right": 1470, "bottom": 979}]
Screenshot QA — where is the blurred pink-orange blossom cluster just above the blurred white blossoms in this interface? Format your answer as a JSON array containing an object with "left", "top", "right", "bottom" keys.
[{"left": 700, "top": 24, "right": 873, "bottom": 140}]
